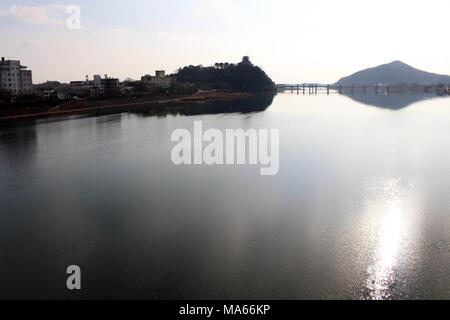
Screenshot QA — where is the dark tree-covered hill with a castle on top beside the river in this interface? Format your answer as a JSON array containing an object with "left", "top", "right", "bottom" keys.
[{"left": 176, "top": 57, "right": 275, "bottom": 92}]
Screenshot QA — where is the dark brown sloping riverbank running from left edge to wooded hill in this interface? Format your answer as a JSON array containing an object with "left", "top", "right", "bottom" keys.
[{"left": 0, "top": 91, "right": 256, "bottom": 121}]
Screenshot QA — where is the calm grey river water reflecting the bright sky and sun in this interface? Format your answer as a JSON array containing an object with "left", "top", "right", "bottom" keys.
[{"left": 0, "top": 93, "right": 450, "bottom": 299}]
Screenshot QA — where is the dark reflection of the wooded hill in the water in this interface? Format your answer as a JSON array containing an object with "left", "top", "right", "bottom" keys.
[{"left": 130, "top": 94, "right": 274, "bottom": 117}]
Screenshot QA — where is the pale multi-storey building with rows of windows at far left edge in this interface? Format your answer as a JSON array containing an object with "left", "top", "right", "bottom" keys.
[{"left": 0, "top": 57, "right": 33, "bottom": 95}]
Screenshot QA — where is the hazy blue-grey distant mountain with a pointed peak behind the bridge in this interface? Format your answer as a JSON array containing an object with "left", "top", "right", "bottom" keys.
[{"left": 336, "top": 61, "right": 450, "bottom": 85}]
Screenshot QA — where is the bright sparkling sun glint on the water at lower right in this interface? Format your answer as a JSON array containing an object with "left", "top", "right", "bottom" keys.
[{"left": 361, "top": 177, "right": 421, "bottom": 300}]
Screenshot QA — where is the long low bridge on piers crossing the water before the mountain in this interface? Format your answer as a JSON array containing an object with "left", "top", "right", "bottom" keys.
[{"left": 277, "top": 83, "right": 445, "bottom": 94}]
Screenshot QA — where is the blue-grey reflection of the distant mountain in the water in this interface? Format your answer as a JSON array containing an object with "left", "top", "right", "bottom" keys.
[{"left": 345, "top": 93, "right": 437, "bottom": 110}]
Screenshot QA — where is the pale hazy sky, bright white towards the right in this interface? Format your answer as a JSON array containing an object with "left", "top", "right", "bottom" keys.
[{"left": 0, "top": 0, "right": 450, "bottom": 83}]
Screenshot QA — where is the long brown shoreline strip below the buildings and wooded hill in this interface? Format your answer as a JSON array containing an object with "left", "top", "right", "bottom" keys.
[{"left": 0, "top": 91, "right": 256, "bottom": 122}]
